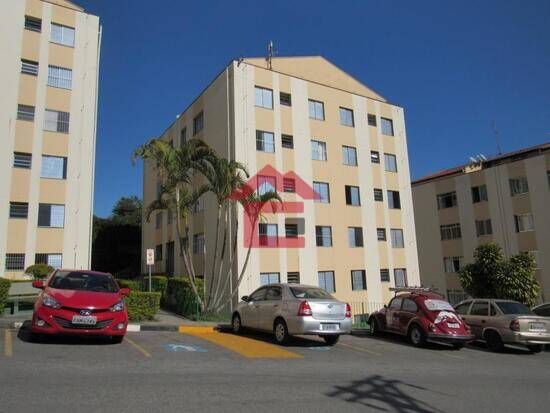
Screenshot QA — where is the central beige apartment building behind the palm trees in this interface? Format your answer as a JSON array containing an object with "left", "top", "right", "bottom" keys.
[{"left": 142, "top": 56, "right": 419, "bottom": 303}]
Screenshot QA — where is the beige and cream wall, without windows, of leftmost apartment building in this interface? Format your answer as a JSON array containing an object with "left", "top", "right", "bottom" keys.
[{"left": 0, "top": 0, "right": 100, "bottom": 278}]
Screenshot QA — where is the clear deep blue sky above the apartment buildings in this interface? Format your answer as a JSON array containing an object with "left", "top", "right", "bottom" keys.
[{"left": 76, "top": 0, "right": 550, "bottom": 216}]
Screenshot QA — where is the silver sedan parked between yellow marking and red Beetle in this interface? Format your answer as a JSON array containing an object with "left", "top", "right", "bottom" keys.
[{"left": 231, "top": 284, "right": 352, "bottom": 345}]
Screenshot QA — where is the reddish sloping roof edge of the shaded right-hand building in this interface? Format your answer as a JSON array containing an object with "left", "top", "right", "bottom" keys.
[{"left": 412, "top": 142, "right": 550, "bottom": 186}]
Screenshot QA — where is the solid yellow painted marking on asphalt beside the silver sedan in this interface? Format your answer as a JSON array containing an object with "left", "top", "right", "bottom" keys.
[{"left": 179, "top": 326, "right": 303, "bottom": 359}]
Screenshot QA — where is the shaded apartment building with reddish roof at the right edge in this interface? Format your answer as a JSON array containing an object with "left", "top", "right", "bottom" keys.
[{"left": 413, "top": 143, "right": 550, "bottom": 301}]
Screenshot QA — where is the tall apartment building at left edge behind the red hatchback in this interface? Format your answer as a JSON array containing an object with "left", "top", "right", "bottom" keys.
[{"left": 0, "top": 0, "right": 100, "bottom": 278}]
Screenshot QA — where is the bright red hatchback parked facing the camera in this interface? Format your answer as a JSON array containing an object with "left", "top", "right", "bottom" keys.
[{"left": 31, "top": 269, "right": 130, "bottom": 343}]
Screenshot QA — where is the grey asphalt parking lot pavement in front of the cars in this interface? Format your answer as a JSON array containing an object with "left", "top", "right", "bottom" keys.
[{"left": 0, "top": 328, "right": 550, "bottom": 412}]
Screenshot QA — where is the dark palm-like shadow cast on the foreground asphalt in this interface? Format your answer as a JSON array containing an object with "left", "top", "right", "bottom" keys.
[{"left": 326, "top": 374, "right": 443, "bottom": 413}]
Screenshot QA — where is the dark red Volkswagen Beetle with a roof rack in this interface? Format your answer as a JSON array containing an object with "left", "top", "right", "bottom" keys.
[{"left": 369, "top": 289, "right": 474, "bottom": 349}]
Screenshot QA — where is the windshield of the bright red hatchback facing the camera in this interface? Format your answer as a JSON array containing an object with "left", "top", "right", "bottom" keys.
[{"left": 49, "top": 271, "right": 118, "bottom": 293}]
